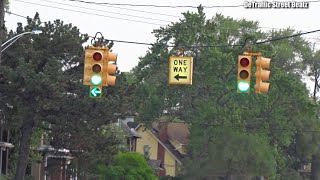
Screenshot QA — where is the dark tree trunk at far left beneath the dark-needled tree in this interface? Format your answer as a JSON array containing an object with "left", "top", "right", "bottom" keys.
[{"left": 14, "top": 108, "right": 35, "bottom": 180}]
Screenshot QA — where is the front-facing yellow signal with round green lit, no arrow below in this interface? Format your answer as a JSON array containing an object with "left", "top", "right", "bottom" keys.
[{"left": 237, "top": 55, "right": 252, "bottom": 93}]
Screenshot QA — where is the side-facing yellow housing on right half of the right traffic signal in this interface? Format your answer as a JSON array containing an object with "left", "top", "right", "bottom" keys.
[{"left": 254, "top": 56, "right": 271, "bottom": 94}]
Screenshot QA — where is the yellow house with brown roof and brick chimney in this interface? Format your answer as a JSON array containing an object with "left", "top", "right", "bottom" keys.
[{"left": 135, "top": 122, "right": 189, "bottom": 177}]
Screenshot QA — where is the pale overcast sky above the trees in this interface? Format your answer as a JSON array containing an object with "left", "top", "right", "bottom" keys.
[{"left": 5, "top": 0, "right": 320, "bottom": 75}]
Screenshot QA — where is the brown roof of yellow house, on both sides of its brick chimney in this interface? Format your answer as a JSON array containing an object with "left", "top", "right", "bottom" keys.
[{"left": 152, "top": 122, "right": 190, "bottom": 145}]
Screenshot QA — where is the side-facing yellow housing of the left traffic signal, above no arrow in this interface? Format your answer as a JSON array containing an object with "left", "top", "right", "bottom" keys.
[{"left": 103, "top": 51, "right": 118, "bottom": 86}]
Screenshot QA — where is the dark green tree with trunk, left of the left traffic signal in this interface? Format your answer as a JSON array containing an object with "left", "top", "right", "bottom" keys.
[{"left": 0, "top": 14, "right": 124, "bottom": 180}]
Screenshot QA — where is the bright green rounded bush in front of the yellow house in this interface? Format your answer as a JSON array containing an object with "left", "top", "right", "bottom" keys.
[{"left": 97, "top": 152, "right": 157, "bottom": 180}]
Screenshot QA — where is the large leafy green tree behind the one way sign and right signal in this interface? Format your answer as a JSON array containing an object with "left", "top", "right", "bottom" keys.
[{"left": 134, "top": 7, "right": 319, "bottom": 179}]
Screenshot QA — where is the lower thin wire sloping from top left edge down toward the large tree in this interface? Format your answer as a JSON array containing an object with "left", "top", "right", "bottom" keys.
[{"left": 16, "top": 0, "right": 163, "bottom": 26}]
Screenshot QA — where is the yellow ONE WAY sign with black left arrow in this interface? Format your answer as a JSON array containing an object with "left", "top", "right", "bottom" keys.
[{"left": 169, "top": 56, "right": 193, "bottom": 84}]
